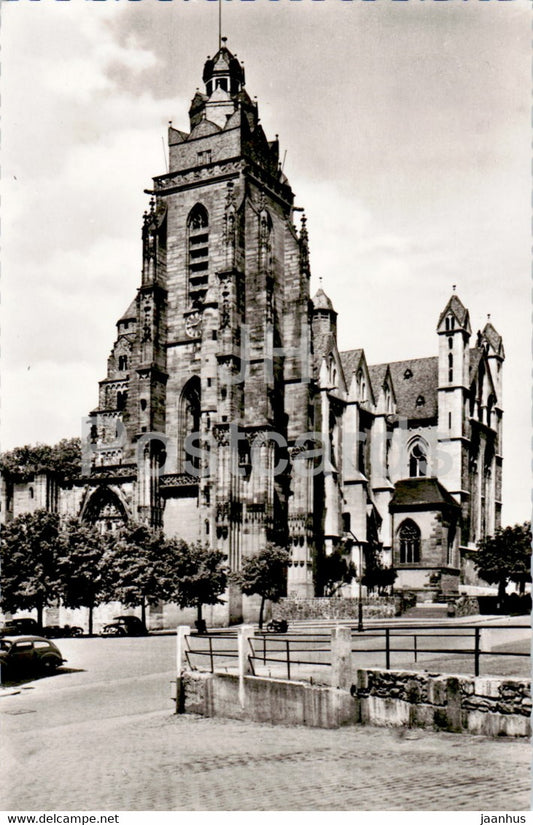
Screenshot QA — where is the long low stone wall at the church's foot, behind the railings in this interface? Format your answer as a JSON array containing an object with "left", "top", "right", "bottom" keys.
[{"left": 272, "top": 597, "right": 394, "bottom": 621}]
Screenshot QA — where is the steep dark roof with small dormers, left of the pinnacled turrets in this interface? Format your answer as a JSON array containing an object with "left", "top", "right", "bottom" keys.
[{"left": 368, "top": 356, "right": 439, "bottom": 419}]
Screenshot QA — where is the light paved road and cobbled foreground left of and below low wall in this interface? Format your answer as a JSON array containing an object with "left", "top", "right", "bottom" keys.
[{"left": 0, "top": 637, "right": 530, "bottom": 811}]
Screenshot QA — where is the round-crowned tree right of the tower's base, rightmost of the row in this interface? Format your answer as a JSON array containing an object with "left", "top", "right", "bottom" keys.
[{"left": 231, "top": 544, "right": 290, "bottom": 629}]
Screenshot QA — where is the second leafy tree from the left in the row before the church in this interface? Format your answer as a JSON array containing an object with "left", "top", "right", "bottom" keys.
[{"left": 58, "top": 518, "right": 109, "bottom": 635}]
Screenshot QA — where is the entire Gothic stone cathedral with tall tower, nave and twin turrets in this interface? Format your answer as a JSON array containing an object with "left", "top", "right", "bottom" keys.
[{"left": 6, "top": 38, "right": 504, "bottom": 621}]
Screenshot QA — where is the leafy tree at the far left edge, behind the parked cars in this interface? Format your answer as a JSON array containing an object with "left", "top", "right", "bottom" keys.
[{"left": 0, "top": 510, "right": 61, "bottom": 625}]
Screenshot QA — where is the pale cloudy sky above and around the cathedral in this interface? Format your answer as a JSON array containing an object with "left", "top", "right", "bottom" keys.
[{"left": 1, "top": 0, "right": 531, "bottom": 523}]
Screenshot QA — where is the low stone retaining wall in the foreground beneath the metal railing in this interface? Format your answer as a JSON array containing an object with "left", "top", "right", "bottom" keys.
[{"left": 181, "top": 669, "right": 531, "bottom": 736}]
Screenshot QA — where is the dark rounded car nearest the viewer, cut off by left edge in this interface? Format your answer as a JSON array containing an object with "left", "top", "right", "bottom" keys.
[{"left": 0, "top": 636, "right": 66, "bottom": 681}]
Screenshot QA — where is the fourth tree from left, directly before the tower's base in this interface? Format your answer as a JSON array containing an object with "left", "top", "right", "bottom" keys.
[{"left": 172, "top": 542, "right": 228, "bottom": 630}]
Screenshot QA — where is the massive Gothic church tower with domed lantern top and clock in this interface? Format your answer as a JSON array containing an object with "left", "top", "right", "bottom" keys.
[{"left": 86, "top": 38, "right": 313, "bottom": 619}]
